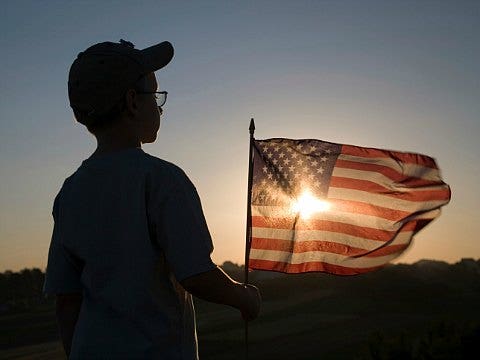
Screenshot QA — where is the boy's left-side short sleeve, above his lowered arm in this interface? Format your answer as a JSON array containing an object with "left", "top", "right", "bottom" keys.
[{"left": 43, "top": 195, "right": 82, "bottom": 294}]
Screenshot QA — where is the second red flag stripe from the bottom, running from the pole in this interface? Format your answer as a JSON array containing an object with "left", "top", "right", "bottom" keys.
[{"left": 251, "top": 237, "right": 409, "bottom": 257}]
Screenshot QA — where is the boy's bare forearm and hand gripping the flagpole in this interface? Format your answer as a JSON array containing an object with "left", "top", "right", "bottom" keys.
[{"left": 180, "top": 266, "right": 261, "bottom": 320}]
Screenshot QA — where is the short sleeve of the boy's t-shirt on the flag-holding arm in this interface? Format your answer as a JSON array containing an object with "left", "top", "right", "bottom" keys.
[{"left": 151, "top": 168, "right": 216, "bottom": 281}]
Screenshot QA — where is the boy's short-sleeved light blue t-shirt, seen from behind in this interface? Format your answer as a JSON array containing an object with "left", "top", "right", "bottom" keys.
[{"left": 44, "top": 148, "right": 215, "bottom": 360}]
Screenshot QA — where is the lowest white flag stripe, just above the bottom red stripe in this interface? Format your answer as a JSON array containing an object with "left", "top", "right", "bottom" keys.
[{"left": 250, "top": 249, "right": 402, "bottom": 268}]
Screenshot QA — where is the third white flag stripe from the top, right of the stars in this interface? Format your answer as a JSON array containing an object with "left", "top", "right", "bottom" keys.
[{"left": 328, "top": 186, "right": 448, "bottom": 213}]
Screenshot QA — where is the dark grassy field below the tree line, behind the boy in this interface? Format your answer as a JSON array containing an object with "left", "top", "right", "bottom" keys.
[{"left": 0, "top": 267, "right": 480, "bottom": 360}]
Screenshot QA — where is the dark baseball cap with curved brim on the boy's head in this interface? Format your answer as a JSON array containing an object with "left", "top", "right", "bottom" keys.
[{"left": 68, "top": 39, "right": 173, "bottom": 125}]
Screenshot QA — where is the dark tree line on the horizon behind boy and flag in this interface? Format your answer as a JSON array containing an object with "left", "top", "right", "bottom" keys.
[{"left": 0, "top": 259, "right": 480, "bottom": 313}]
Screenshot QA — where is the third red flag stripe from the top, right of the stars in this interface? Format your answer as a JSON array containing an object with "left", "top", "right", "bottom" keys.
[{"left": 330, "top": 176, "right": 450, "bottom": 202}]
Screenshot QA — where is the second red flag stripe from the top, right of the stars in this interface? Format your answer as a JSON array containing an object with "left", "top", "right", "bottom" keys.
[{"left": 335, "top": 159, "right": 439, "bottom": 188}]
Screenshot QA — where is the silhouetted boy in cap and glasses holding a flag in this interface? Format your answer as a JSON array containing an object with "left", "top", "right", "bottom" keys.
[{"left": 44, "top": 40, "right": 260, "bottom": 359}]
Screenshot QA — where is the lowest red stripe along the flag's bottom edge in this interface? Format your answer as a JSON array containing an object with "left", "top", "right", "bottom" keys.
[{"left": 248, "top": 259, "right": 385, "bottom": 275}]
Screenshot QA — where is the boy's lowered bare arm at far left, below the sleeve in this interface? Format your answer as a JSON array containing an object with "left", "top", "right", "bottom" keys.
[{"left": 55, "top": 293, "right": 83, "bottom": 357}]
